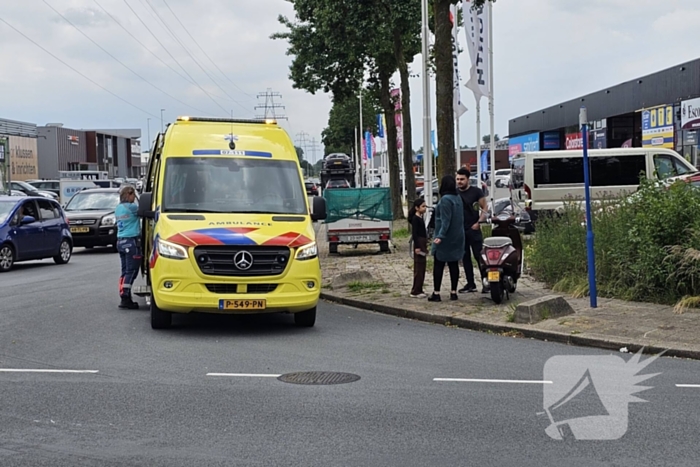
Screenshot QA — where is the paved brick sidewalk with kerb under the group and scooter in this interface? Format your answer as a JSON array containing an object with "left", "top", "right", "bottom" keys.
[{"left": 317, "top": 223, "right": 700, "bottom": 359}]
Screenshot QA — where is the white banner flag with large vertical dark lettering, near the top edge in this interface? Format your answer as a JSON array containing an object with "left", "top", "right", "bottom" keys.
[{"left": 462, "top": 0, "right": 490, "bottom": 101}]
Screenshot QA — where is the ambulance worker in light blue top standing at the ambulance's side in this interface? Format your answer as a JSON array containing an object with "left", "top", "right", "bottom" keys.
[{"left": 114, "top": 185, "right": 142, "bottom": 310}]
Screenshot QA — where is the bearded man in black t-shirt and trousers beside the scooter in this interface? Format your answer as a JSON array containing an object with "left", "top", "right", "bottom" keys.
[{"left": 457, "top": 167, "right": 487, "bottom": 293}]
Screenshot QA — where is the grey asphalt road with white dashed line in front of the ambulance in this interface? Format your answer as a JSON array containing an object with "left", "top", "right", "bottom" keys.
[{"left": 0, "top": 250, "right": 700, "bottom": 467}]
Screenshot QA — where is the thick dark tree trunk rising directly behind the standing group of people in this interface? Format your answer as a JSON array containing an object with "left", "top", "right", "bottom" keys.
[{"left": 434, "top": 0, "right": 457, "bottom": 178}]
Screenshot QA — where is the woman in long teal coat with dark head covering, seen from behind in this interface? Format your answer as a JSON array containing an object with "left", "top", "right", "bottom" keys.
[{"left": 428, "top": 175, "right": 464, "bottom": 302}]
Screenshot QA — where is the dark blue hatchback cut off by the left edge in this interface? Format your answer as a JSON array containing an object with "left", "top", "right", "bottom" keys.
[{"left": 0, "top": 196, "right": 73, "bottom": 272}]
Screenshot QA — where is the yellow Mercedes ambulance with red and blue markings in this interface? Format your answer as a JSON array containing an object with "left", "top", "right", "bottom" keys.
[{"left": 135, "top": 117, "right": 326, "bottom": 329}]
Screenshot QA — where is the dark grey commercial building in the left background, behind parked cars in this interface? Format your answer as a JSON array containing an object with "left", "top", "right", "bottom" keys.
[{"left": 37, "top": 123, "right": 141, "bottom": 179}]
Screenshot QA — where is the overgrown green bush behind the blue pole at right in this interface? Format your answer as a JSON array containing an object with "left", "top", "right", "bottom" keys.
[{"left": 528, "top": 180, "right": 700, "bottom": 303}]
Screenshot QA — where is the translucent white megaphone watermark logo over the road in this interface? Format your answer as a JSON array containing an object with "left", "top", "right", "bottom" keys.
[{"left": 543, "top": 350, "right": 661, "bottom": 440}]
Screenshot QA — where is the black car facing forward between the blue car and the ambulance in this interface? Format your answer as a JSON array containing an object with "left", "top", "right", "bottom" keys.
[{"left": 65, "top": 188, "right": 131, "bottom": 251}]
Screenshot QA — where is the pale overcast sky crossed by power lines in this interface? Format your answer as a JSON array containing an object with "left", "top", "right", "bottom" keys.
[{"left": 0, "top": 0, "right": 700, "bottom": 164}]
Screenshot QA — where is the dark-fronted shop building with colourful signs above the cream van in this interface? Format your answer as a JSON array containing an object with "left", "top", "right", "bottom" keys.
[{"left": 508, "top": 59, "right": 700, "bottom": 166}]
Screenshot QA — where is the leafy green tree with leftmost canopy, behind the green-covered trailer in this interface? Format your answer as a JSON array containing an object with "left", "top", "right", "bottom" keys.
[{"left": 272, "top": 0, "right": 420, "bottom": 218}]
